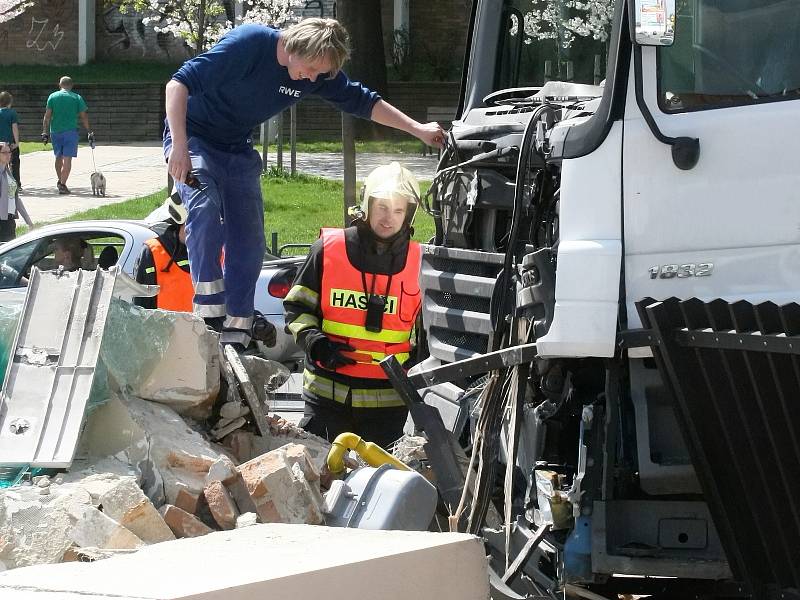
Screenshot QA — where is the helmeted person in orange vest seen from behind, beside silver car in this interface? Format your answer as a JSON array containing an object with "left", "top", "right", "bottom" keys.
[{"left": 134, "top": 198, "right": 194, "bottom": 312}]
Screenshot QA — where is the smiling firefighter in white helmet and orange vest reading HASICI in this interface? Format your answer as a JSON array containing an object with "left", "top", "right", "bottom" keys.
[{"left": 283, "top": 162, "right": 421, "bottom": 448}]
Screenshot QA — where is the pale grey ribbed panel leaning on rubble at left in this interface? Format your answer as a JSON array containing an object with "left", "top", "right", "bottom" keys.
[{"left": 0, "top": 269, "right": 116, "bottom": 468}]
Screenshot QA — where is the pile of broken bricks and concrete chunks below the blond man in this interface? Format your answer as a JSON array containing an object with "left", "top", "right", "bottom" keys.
[{"left": 0, "top": 300, "right": 329, "bottom": 571}]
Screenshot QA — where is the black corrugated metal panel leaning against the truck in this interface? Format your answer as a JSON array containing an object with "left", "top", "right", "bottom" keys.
[{"left": 637, "top": 299, "right": 800, "bottom": 598}]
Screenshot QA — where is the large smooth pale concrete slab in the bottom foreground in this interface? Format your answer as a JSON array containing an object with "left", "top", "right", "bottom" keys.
[{"left": 0, "top": 524, "right": 489, "bottom": 600}]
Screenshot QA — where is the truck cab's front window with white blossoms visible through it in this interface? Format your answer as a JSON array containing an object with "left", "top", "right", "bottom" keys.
[{"left": 494, "top": 0, "right": 615, "bottom": 91}]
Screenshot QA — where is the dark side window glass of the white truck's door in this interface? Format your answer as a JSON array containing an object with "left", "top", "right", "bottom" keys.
[{"left": 659, "top": 0, "right": 800, "bottom": 112}]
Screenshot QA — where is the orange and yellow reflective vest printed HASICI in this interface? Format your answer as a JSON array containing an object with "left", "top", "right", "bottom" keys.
[{"left": 320, "top": 229, "right": 421, "bottom": 379}]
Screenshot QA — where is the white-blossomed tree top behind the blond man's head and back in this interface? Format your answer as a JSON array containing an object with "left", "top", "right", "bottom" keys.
[{"left": 108, "top": 0, "right": 301, "bottom": 55}]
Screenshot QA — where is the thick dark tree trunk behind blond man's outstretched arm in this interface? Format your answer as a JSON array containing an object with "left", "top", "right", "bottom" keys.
[{"left": 336, "top": 0, "right": 387, "bottom": 139}]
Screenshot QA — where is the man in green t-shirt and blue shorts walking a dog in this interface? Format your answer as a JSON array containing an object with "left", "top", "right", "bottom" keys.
[{"left": 42, "top": 75, "right": 94, "bottom": 194}]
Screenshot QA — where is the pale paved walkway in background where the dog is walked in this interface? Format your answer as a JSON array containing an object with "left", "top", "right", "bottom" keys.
[{"left": 20, "top": 142, "right": 437, "bottom": 223}]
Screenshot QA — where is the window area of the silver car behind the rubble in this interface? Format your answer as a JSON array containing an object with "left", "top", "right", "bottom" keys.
[{"left": 0, "top": 232, "right": 125, "bottom": 288}]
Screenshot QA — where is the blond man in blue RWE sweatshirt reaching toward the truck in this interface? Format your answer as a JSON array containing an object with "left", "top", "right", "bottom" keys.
[{"left": 164, "top": 18, "right": 444, "bottom": 347}]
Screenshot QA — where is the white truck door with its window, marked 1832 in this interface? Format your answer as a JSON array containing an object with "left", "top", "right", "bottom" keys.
[{"left": 623, "top": 0, "right": 800, "bottom": 327}]
